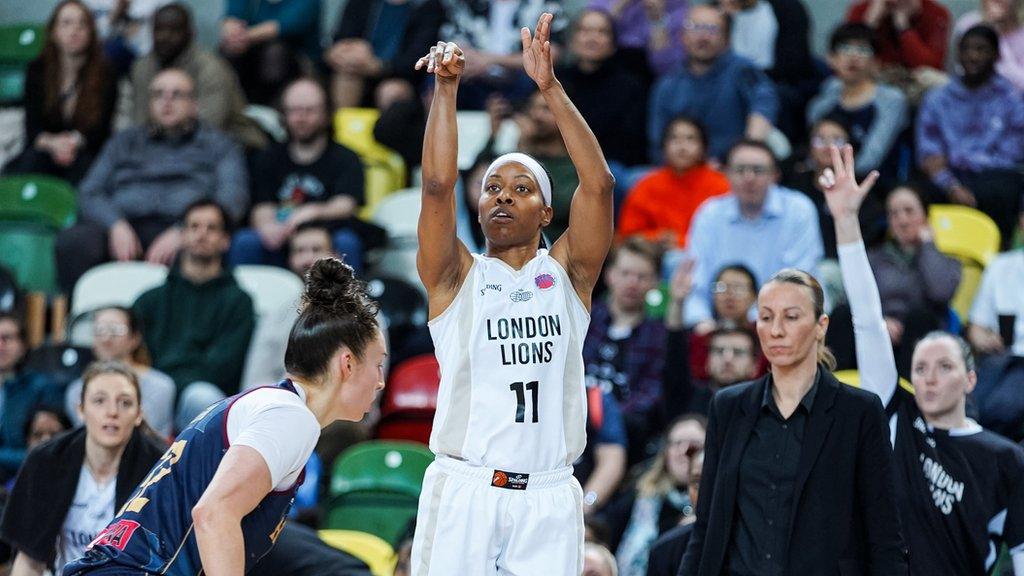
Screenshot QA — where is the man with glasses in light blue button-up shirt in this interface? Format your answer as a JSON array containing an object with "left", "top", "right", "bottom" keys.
[{"left": 683, "top": 140, "right": 824, "bottom": 331}]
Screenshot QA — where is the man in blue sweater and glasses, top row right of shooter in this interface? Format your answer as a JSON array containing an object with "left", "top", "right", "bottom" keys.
[{"left": 647, "top": 5, "right": 778, "bottom": 162}]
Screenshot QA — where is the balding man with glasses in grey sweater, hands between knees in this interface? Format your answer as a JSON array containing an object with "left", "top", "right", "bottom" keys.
[{"left": 56, "top": 69, "right": 249, "bottom": 293}]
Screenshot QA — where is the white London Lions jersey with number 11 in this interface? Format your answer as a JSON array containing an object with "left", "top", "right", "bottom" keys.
[{"left": 429, "top": 249, "right": 590, "bottom": 474}]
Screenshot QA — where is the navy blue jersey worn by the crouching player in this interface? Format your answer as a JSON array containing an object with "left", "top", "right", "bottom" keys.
[{"left": 63, "top": 380, "right": 304, "bottom": 576}]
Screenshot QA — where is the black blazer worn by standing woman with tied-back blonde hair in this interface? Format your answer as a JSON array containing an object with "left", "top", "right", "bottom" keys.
[{"left": 679, "top": 368, "right": 907, "bottom": 576}]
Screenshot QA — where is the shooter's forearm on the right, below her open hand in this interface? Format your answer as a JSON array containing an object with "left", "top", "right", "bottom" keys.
[{"left": 542, "top": 81, "right": 613, "bottom": 194}]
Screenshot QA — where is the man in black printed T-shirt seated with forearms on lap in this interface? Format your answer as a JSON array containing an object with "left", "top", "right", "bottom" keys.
[{"left": 228, "top": 78, "right": 364, "bottom": 273}]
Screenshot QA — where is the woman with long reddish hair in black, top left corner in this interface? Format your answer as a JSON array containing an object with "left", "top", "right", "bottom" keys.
[{"left": 7, "top": 0, "right": 117, "bottom": 183}]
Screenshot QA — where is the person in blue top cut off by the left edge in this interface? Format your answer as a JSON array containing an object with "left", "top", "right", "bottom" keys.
[{"left": 0, "top": 313, "right": 61, "bottom": 482}]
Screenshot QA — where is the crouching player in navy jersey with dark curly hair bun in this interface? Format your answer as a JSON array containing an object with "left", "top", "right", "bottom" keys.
[{"left": 63, "top": 258, "right": 387, "bottom": 576}]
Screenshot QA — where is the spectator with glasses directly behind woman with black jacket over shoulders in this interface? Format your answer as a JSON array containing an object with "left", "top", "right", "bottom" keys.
[{"left": 65, "top": 306, "right": 177, "bottom": 438}]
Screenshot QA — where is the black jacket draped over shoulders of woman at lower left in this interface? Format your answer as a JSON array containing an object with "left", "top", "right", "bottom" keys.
[{"left": 0, "top": 426, "right": 167, "bottom": 566}]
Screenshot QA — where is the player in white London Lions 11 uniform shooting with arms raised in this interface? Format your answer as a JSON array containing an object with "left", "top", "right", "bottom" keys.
[{"left": 412, "top": 13, "right": 614, "bottom": 576}]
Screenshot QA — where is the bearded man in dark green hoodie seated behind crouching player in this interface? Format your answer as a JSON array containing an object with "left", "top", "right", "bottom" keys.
[{"left": 132, "top": 200, "right": 256, "bottom": 430}]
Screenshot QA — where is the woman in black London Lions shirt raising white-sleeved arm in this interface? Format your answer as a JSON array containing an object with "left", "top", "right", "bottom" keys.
[{"left": 821, "top": 146, "right": 1024, "bottom": 576}]
